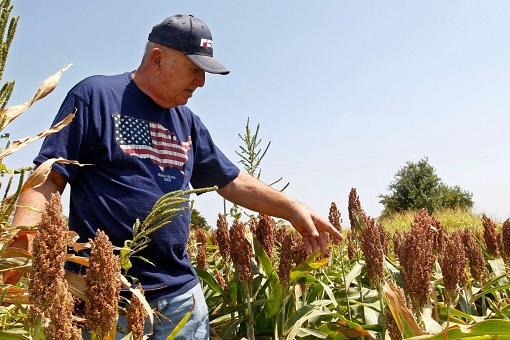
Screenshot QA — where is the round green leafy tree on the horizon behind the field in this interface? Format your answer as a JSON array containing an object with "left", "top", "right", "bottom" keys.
[{"left": 379, "top": 158, "right": 474, "bottom": 216}]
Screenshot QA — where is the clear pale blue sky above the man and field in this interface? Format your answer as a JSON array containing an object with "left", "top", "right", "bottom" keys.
[{"left": 3, "top": 0, "right": 510, "bottom": 226}]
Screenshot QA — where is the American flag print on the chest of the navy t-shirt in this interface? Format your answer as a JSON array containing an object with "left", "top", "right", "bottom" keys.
[{"left": 112, "top": 113, "right": 191, "bottom": 174}]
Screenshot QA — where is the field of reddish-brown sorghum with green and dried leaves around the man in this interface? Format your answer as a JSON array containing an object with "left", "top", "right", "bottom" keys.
[{"left": 0, "top": 0, "right": 510, "bottom": 340}]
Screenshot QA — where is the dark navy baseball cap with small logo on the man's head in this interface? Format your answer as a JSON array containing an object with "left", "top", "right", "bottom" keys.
[{"left": 149, "top": 14, "right": 230, "bottom": 74}]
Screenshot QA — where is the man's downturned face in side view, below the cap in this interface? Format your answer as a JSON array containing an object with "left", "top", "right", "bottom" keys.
[{"left": 156, "top": 48, "right": 205, "bottom": 108}]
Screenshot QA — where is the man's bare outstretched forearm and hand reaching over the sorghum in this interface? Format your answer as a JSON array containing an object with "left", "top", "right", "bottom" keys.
[{"left": 218, "top": 173, "right": 342, "bottom": 255}]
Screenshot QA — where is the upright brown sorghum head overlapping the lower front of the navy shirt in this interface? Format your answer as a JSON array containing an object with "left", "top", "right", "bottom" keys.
[{"left": 85, "top": 230, "right": 121, "bottom": 339}]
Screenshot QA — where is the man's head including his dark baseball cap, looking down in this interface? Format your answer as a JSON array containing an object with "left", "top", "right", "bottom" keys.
[{"left": 132, "top": 15, "right": 230, "bottom": 108}]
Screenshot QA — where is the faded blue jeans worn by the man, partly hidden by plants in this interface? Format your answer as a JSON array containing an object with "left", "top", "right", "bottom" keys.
[{"left": 82, "top": 284, "right": 209, "bottom": 340}]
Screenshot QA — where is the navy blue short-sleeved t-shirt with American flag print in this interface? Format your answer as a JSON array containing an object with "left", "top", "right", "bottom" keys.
[{"left": 34, "top": 72, "right": 239, "bottom": 301}]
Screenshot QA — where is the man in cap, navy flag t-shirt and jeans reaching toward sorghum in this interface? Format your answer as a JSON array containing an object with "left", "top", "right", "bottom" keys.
[{"left": 4, "top": 15, "right": 342, "bottom": 339}]
